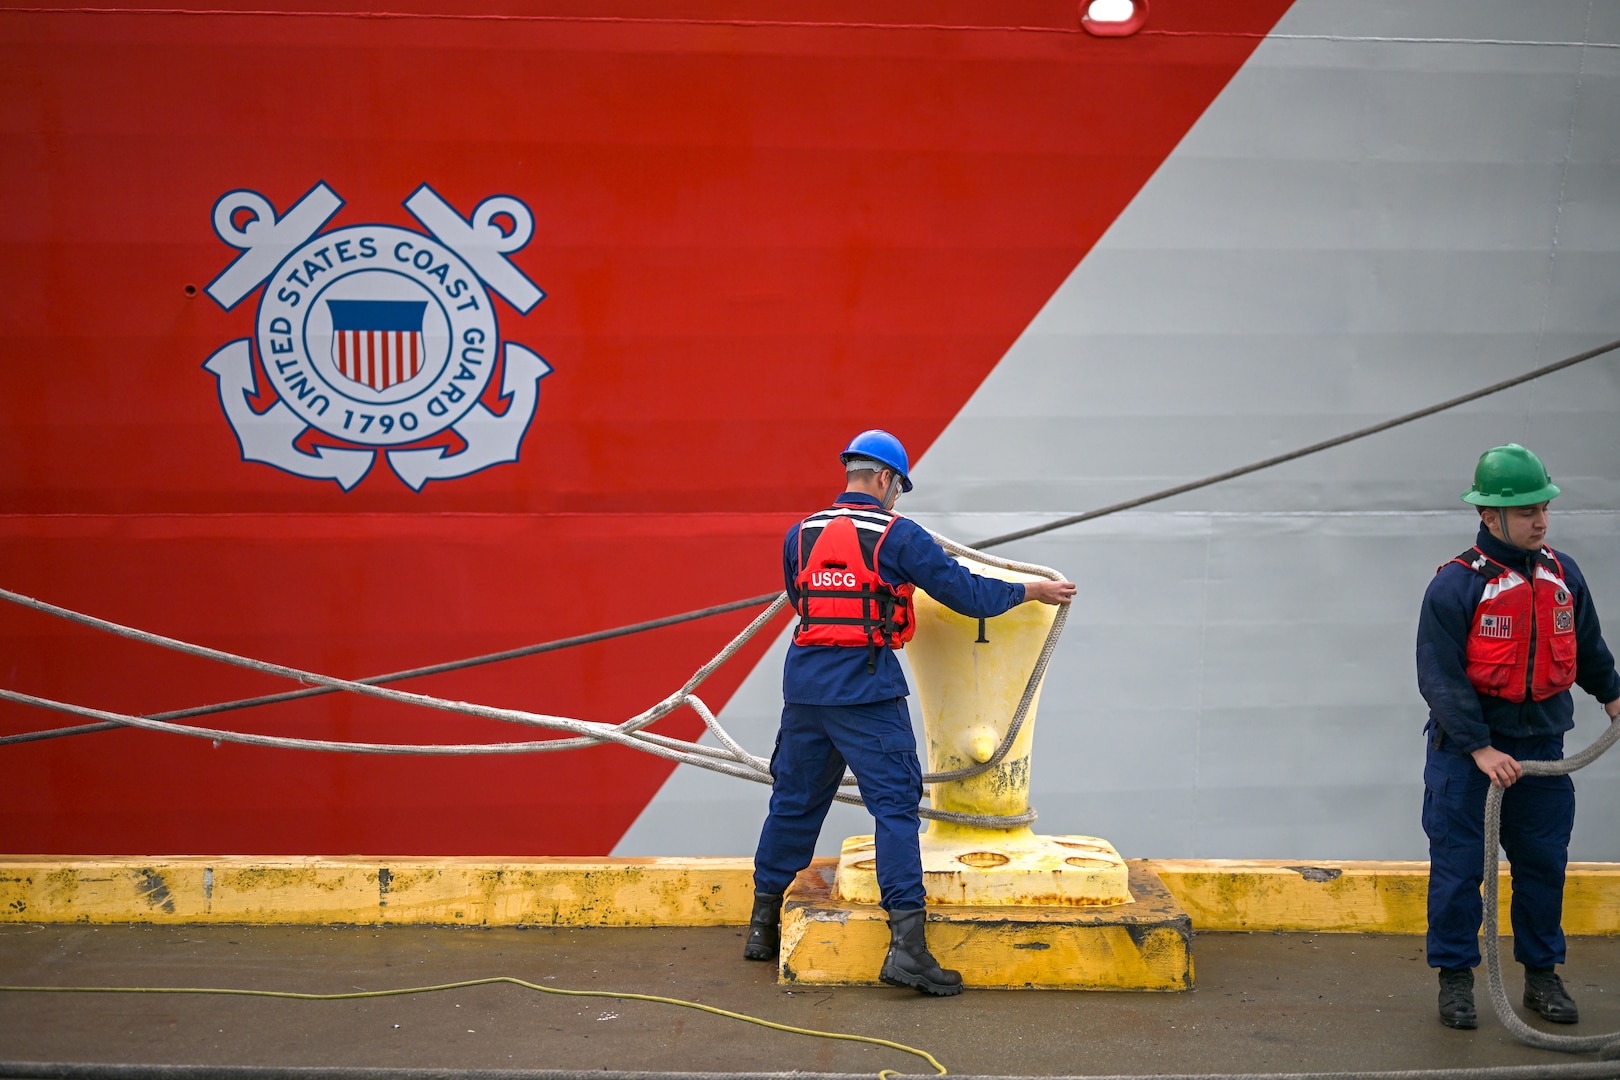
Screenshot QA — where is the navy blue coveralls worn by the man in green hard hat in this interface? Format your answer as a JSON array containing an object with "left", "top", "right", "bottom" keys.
[{"left": 1418, "top": 526, "right": 1620, "bottom": 970}]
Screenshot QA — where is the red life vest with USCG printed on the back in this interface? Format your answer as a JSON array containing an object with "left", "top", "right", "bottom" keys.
[{"left": 794, "top": 505, "right": 917, "bottom": 672}]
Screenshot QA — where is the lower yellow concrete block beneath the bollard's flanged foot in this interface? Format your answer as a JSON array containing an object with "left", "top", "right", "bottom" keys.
[{"left": 779, "top": 860, "right": 1192, "bottom": 991}]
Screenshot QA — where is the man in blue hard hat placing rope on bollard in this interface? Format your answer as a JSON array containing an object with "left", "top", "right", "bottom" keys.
[{"left": 744, "top": 431, "right": 1074, "bottom": 996}]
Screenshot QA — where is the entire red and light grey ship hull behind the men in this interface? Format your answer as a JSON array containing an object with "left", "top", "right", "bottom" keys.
[{"left": 0, "top": 0, "right": 1620, "bottom": 860}]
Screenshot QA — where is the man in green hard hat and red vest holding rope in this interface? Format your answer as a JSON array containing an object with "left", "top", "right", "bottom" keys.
[{"left": 1418, "top": 444, "right": 1620, "bottom": 1028}]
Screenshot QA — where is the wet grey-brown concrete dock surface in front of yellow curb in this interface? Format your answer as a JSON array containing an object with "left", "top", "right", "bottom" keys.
[{"left": 0, "top": 923, "right": 1620, "bottom": 1075}]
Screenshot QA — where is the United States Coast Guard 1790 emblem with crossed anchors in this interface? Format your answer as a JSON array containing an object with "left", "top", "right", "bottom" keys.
[{"left": 204, "top": 183, "right": 551, "bottom": 491}]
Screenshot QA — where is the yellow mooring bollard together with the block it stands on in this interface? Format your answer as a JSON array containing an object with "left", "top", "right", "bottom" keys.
[{"left": 778, "top": 559, "right": 1192, "bottom": 991}]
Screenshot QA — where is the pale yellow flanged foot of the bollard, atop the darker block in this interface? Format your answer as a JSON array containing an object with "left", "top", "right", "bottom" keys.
[{"left": 833, "top": 829, "right": 1131, "bottom": 907}]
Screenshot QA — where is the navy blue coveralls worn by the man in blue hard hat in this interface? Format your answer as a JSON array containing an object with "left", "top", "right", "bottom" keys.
[{"left": 753, "top": 491, "right": 1024, "bottom": 912}]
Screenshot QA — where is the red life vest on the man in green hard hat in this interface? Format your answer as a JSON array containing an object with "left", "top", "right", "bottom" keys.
[{"left": 1452, "top": 547, "right": 1575, "bottom": 701}]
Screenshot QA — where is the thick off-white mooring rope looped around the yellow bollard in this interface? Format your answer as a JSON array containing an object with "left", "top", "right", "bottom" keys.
[{"left": 0, "top": 533, "right": 1068, "bottom": 829}]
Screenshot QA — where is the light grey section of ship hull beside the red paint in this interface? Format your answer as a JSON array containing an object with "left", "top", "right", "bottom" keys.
[{"left": 616, "top": 0, "right": 1620, "bottom": 860}]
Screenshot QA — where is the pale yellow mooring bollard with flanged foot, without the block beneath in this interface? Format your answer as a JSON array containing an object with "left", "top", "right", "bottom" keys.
[{"left": 834, "top": 559, "right": 1131, "bottom": 905}]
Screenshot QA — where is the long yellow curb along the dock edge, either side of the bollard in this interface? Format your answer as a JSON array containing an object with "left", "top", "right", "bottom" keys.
[{"left": 9, "top": 855, "right": 1620, "bottom": 934}]
